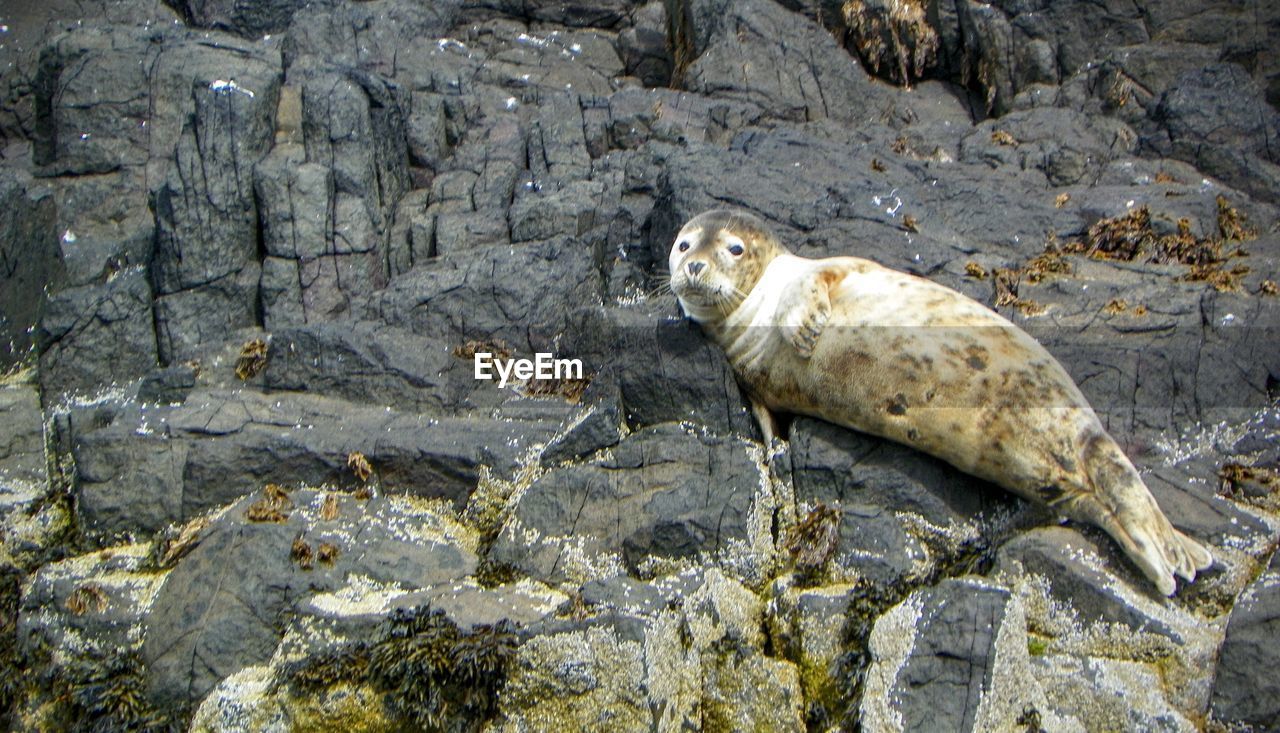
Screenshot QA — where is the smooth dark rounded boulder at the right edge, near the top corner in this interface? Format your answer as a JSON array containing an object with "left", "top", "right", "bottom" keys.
[{"left": 1147, "top": 64, "right": 1280, "bottom": 203}]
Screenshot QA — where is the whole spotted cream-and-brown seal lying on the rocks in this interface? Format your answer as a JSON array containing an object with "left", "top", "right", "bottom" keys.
[{"left": 668, "top": 210, "right": 1213, "bottom": 595}]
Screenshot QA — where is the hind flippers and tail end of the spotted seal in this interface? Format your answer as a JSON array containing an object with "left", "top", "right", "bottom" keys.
[{"left": 1076, "top": 434, "right": 1213, "bottom": 596}]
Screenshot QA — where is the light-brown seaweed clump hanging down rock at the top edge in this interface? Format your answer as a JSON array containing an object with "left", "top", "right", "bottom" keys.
[{"left": 841, "top": 0, "right": 938, "bottom": 86}]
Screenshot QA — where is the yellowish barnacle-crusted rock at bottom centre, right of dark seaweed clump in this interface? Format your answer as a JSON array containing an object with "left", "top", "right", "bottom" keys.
[{"left": 495, "top": 569, "right": 804, "bottom": 730}]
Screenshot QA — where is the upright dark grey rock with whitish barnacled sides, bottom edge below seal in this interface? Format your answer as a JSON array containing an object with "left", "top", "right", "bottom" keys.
[{"left": 860, "top": 578, "right": 1082, "bottom": 730}]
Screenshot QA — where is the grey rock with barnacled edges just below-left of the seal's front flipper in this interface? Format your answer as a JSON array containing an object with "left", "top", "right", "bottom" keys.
[{"left": 490, "top": 425, "right": 774, "bottom": 581}]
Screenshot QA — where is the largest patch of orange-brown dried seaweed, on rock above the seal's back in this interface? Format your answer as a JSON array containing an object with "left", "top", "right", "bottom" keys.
[{"left": 1068, "top": 202, "right": 1256, "bottom": 290}]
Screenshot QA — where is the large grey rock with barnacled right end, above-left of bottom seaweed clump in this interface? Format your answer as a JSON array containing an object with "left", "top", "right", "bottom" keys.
[{"left": 142, "top": 491, "right": 476, "bottom": 710}]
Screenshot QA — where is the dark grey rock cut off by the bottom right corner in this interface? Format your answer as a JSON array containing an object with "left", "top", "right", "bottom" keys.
[{"left": 1210, "top": 547, "right": 1280, "bottom": 729}]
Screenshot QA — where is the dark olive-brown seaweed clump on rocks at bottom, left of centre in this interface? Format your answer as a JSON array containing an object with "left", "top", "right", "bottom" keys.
[{"left": 293, "top": 608, "right": 516, "bottom": 732}]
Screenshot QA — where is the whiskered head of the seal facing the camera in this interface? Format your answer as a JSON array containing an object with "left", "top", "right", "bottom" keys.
[{"left": 667, "top": 209, "right": 786, "bottom": 319}]
